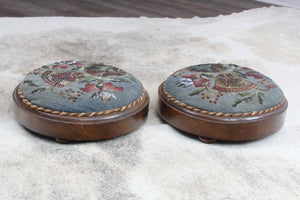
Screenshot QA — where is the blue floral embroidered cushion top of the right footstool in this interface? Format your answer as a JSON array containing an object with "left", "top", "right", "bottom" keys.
[{"left": 165, "top": 64, "right": 284, "bottom": 113}]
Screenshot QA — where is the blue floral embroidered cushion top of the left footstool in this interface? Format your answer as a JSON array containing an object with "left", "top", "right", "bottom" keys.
[{"left": 20, "top": 61, "right": 143, "bottom": 113}]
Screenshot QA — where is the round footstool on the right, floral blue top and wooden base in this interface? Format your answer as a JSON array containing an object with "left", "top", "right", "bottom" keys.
[{"left": 159, "top": 64, "right": 287, "bottom": 143}]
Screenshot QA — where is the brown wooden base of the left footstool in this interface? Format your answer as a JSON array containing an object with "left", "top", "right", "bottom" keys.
[{"left": 13, "top": 89, "right": 149, "bottom": 143}]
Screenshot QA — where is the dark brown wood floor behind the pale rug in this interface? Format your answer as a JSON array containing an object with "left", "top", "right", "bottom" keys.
[{"left": 0, "top": 0, "right": 271, "bottom": 18}]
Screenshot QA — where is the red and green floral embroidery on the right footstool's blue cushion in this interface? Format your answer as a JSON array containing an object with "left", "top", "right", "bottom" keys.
[{"left": 173, "top": 64, "right": 277, "bottom": 107}]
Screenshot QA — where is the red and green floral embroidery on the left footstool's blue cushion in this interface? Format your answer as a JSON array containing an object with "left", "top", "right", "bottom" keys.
[{"left": 23, "top": 61, "right": 137, "bottom": 104}]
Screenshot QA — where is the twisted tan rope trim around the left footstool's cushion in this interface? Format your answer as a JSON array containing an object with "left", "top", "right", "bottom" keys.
[{"left": 17, "top": 85, "right": 146, "bottom": 117}]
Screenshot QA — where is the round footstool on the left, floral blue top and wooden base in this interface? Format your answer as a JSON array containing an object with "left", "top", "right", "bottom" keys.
[{"left": 13, "top": 61, "right": 149, "bottom": 143}]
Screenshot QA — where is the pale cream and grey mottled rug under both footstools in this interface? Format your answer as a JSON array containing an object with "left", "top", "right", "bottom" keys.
[{"left": 0, "top": 8, "right": 300, "bottom": 200}]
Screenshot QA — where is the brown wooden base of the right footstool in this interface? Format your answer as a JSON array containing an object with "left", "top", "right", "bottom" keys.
[{"left": 159, "top": 84, "right": 287, "bottom": 143}]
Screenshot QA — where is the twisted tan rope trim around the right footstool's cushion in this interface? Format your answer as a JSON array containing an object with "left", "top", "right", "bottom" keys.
[{"left": 163, "top": 82, "right": 285, "bottom": 117}]
